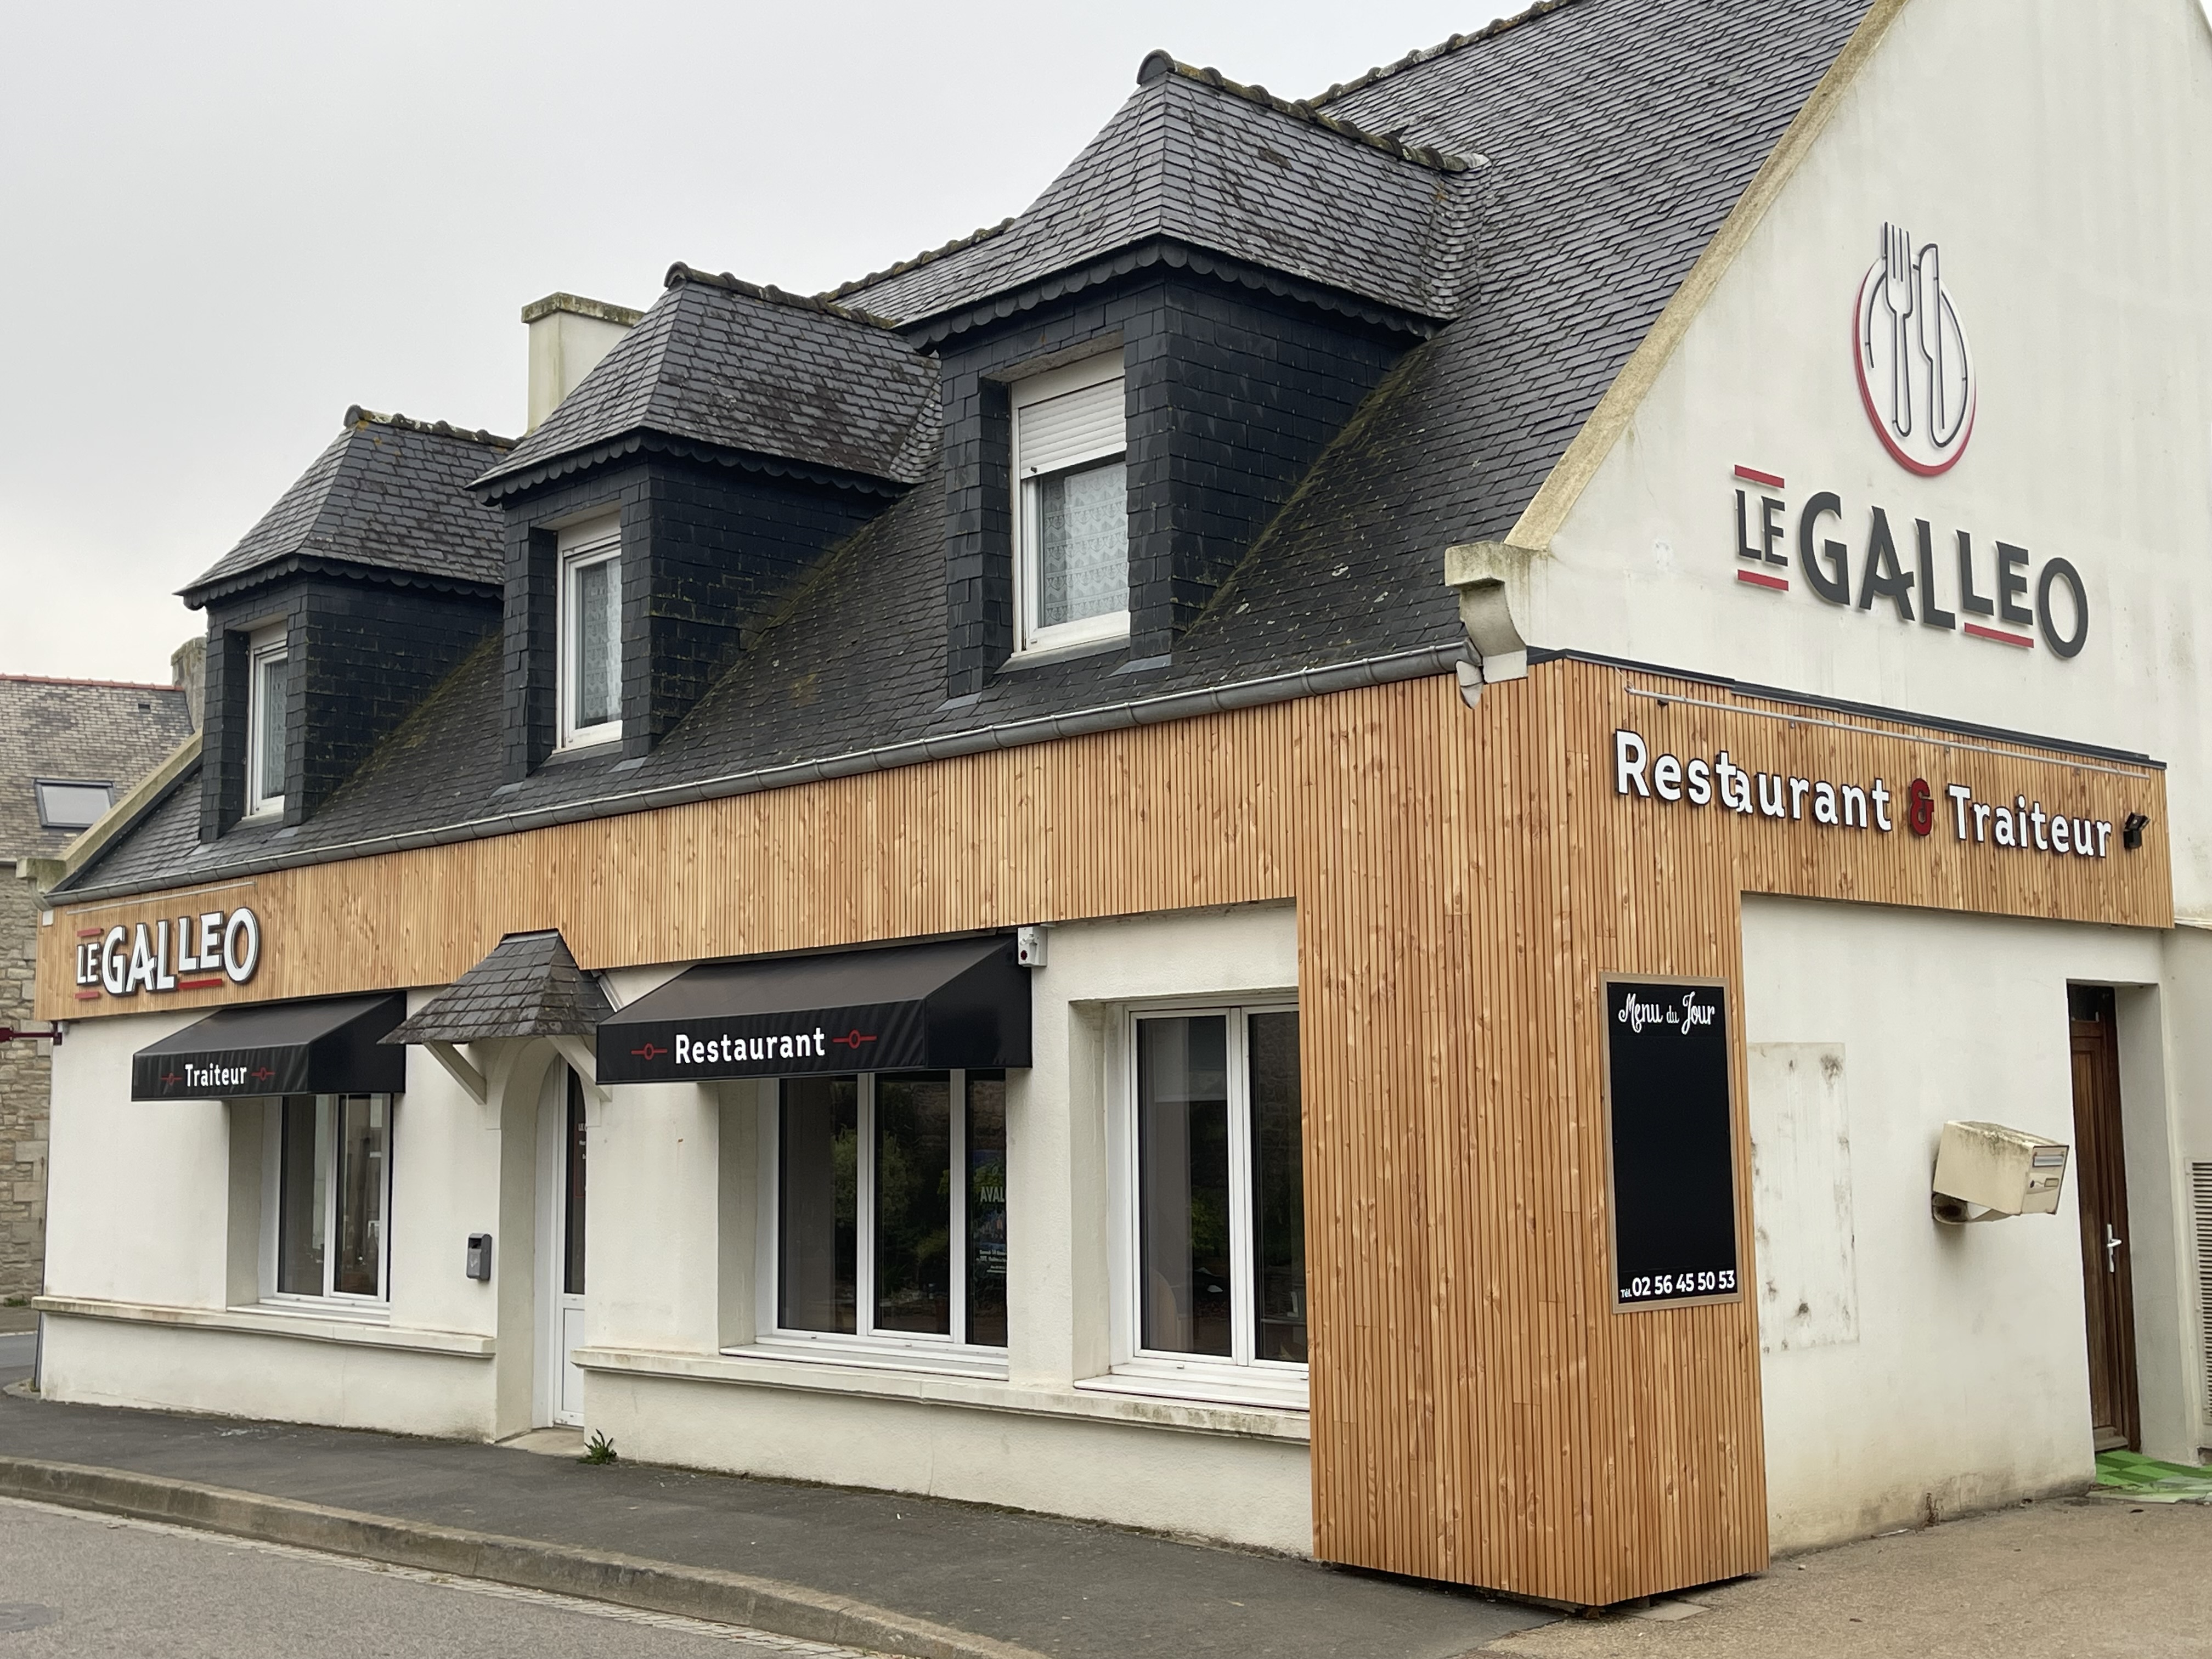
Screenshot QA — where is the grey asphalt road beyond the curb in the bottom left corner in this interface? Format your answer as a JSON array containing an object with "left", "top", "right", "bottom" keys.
[{"left": 0, "top": 1500, "right": 860, "bottom": 1659}]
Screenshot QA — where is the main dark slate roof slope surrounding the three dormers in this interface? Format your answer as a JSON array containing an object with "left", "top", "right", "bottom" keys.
[{"left": 60, "top": 0, "right": 1865, "bottom": 911}]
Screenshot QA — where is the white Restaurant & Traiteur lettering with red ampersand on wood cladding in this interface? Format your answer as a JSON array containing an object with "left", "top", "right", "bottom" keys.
[{"left": 1612, "top": 728, "right": 2113, "bottom": 858}]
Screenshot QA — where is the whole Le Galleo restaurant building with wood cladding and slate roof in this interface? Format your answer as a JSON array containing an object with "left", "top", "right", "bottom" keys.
[{"left": 21, "top": 0, "right": 2212, "bottom": 1604}]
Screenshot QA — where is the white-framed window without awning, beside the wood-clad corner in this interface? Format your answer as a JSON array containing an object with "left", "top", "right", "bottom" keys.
[{"left": 1130, "top": 1009, "right": 1305, "bottom": 1380}]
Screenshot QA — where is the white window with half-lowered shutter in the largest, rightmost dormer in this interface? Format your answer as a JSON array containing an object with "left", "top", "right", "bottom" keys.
[{"left": 1009, "top": 352, "right": 1128, "bottom": 652}]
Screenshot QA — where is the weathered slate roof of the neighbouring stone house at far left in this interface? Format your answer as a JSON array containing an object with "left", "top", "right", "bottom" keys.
[{"left": 0, "top": 675, "right": 193, "bottom": 862}]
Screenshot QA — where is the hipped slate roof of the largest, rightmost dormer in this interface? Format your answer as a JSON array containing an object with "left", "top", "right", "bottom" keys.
[{"left": 836, "top": 53, "right": 1473, "bottom": 323}]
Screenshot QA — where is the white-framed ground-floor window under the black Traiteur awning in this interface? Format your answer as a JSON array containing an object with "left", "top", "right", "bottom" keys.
[{"left": 261, "top": 1095, "right": 394, "bottom": 1312}]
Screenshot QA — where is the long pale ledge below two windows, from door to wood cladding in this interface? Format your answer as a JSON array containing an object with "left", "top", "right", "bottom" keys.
[{"left": 573, "top": 1345, "right": 1310, "bottom": 1444}]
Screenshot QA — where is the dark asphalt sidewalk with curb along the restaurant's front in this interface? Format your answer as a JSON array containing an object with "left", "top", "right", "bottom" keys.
[{"left": 0, "top": 1378, "right": 1553, "bottom": 1659}]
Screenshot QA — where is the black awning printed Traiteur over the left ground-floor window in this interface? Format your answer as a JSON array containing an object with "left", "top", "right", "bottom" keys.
[{"left": 131, "top": 993, "right": 407, "bottom": 1099}]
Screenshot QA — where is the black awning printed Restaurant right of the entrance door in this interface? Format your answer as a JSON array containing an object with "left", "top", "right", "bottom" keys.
[{"left": 600, "top": 934, "right": 1029, "bottom": 1084}]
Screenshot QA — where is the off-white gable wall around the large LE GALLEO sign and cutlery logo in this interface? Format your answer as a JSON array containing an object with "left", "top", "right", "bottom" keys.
[{"left": 1515, "top": 0, "right": 2212, "bottom": 920}]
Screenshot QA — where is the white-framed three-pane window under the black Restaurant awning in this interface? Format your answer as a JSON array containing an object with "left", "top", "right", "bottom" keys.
[{"left": 759, "top": 1070, "right": 1007, "bottom": 1374}]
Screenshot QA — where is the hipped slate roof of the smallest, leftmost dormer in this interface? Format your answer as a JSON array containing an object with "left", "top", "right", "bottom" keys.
[{"left": 182, "top": 405, "right": 513, "bottom": 606}]
